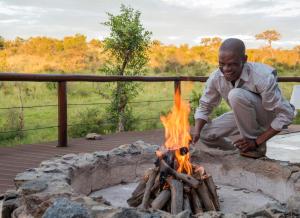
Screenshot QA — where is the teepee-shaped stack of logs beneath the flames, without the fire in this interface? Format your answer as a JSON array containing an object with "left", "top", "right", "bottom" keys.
[{"left": 127, "top": 159, "right": 220, "bottom": 215}]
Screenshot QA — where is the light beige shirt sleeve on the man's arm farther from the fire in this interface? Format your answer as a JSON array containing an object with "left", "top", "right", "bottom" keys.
[{"left": 260, "top": 76, "right": 294, "bottom": 131}]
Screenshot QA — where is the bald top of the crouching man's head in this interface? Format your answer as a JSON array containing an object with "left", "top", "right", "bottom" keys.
[{"left": 219, "top": 38, "right": 245, "bottom": 57}]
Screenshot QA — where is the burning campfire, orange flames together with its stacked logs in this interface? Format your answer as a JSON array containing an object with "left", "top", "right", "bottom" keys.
[{"left": 127, "top": 90, "right": 220, "bottom": 214}]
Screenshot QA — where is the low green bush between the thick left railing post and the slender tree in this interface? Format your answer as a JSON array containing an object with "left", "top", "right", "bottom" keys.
[{"left": 69, "top": 108, "right": 108, "bottom": 137}]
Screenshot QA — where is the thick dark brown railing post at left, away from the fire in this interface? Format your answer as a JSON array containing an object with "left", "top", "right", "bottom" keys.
[{"left": 57, "top": 81, "right": 68, "bottom": 147}]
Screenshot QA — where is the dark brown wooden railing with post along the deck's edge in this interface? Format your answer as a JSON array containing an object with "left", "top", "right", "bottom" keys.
[{"left": 0, "top": 73, "right": 300, "bottom": 147}]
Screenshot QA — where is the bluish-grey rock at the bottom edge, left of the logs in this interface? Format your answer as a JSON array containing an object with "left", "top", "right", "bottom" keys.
[{"left": 43, "top": 198, "right": 91, "bottom": 218}]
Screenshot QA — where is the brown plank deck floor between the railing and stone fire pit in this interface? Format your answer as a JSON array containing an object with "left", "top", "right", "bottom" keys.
[{"left": 0, "top": 130, "right": 164, "bottom": 195}]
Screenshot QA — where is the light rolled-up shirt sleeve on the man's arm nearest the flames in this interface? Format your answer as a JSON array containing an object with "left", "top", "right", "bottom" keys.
[{"left": 194, "top": 76, "right": 221, "bottom": 122}]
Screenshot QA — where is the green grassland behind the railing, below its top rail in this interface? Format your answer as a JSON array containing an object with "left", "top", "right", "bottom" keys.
[{"left": 0, "top": 71, "right": 300, "bottom": 146}]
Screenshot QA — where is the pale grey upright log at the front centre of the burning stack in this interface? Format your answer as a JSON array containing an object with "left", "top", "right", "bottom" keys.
[{"left": 168, "top": 177, "right": 183, "bottom": 215}]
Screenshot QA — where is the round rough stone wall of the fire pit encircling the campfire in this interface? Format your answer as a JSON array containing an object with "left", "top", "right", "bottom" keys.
[{"left": 2, "top": 141, "right": 300, "bottom": 218}]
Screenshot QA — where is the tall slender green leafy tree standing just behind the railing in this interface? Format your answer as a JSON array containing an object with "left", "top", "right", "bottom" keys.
[{"left": 102, "top": 5, "right": 151, "bottom": 131}]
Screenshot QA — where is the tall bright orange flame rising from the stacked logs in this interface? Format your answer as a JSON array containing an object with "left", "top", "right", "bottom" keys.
[{"left": 160, "top": 89, "right": 192, "bottom": 175}]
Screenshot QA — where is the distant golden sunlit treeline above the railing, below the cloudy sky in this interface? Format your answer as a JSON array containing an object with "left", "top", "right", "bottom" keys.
[{"left": 0, "top": 34, "right": 300, "bottom": 75}]
